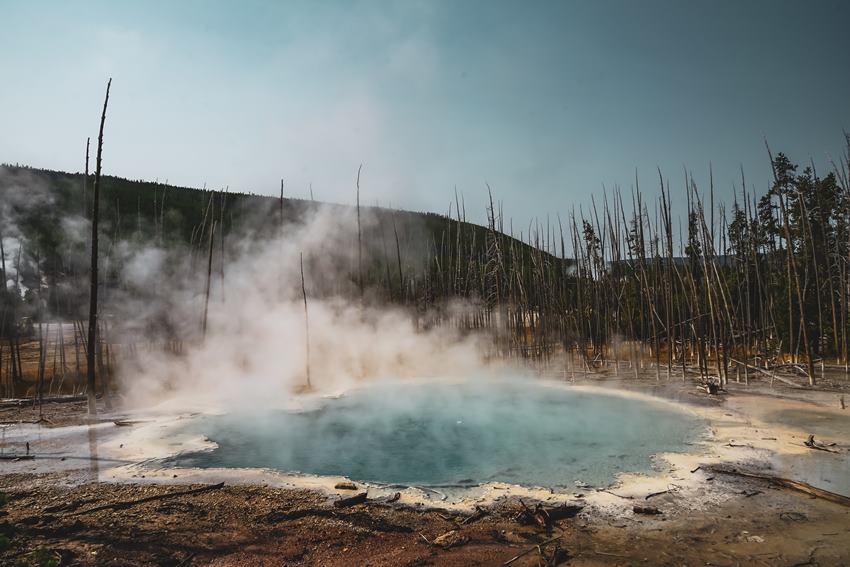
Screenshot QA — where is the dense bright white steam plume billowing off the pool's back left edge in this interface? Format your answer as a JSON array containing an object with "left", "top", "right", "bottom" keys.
[{"left": 115, "top": 206, "right": 494, "bottom": 409}]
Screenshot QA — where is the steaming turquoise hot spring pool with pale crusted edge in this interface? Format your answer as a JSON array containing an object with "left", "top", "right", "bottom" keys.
[{"left": 171, "top": 380, "right": 703, "bottom": 487}]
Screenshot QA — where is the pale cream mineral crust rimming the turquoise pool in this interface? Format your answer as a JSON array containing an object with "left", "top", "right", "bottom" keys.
[{"left": 3, "top": 381, "right": 846, "bottom": 515}]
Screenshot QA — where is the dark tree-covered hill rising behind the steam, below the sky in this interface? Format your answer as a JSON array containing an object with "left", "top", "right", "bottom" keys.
[{"left": 0, "top": 165, "right": 566, "bottom": 324}]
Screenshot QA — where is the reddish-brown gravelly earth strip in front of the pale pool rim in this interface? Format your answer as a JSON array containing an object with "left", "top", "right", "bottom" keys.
[{"left": 0, "top": 390, "right": 850, "bottom": 567}]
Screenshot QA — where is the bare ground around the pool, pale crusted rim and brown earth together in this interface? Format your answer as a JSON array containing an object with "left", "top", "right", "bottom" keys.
[{"left": 0, "top": 381, "right": 850, "bottom": 566}]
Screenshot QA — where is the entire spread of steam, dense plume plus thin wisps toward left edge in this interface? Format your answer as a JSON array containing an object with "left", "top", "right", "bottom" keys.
[{"left": 0, "top": 168, "right": 504, "bottom": 410}]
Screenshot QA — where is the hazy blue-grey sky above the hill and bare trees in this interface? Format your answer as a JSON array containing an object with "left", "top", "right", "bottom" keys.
[{"left": 0, "top": 0, "right": 850, "bottom": 226}]
